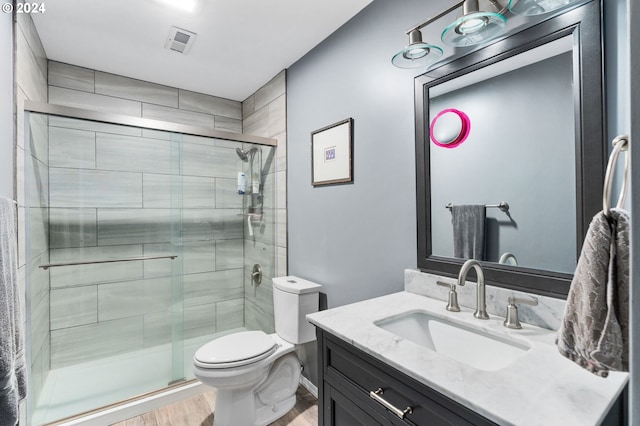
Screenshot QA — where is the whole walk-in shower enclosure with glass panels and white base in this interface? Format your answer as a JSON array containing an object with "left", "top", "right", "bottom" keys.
[{"left": 19, "top": 104, "right": 275, "bottom": 425}]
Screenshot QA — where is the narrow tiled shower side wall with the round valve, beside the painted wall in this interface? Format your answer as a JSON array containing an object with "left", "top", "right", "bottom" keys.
[{"left": 242, "top": 70, "right": 287, "bottom": 333}]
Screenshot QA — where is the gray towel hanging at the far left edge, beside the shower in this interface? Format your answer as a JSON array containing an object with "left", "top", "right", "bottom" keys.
[{"left": 0, "top": 197, "right": 27, "bottom": 426}]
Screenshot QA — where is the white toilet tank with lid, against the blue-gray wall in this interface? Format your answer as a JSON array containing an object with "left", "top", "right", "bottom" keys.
[{"left": 273, "top": 276, "right": 322, "bottom": 344}]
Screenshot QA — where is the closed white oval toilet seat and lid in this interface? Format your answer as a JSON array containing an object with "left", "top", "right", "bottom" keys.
[{"left": 193, "top": 330, "right": 278, "bottom": 369}]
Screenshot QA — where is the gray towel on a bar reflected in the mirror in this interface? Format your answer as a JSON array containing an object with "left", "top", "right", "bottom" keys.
[{"left": 451, "top": 204, "right": 486, "bottom": 260}]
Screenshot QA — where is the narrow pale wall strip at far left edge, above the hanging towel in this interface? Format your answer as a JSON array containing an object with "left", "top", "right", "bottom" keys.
[{"left": 0, "top": 13, "right": 15, "bottom": 200}]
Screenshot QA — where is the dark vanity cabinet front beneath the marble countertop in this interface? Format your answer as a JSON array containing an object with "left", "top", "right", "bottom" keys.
[{"left": 317, "top": 328, "right": 495, "bottom": 426}]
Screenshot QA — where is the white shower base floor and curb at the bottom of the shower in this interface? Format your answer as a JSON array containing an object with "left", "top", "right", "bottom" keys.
[{"left": 30, "top": 328, "right": 245, "bottom": 426}]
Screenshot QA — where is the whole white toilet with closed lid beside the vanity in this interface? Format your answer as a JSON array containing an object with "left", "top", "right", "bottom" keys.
[{"left": 193, "top": 276, "right": 321, "bottom": 426}]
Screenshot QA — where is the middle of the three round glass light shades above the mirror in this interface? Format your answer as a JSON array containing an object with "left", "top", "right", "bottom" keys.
[{"left": 442, "top": 12, "right": 507, "bottom": 47}]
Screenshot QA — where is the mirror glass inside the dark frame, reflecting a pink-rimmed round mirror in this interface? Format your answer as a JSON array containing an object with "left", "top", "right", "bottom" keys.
[{"left": 428, "top": 35, "right": 577, "bottom": 273}]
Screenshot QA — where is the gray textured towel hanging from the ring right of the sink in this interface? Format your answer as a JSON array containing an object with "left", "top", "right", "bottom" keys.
[{"left": 556, "top": 209, "right": 630, "bottom": 377}]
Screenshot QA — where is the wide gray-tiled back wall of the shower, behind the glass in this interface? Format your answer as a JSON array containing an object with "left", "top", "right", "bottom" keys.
[{"left": 49, "top": 61, "right": 252, "bottom": 368}]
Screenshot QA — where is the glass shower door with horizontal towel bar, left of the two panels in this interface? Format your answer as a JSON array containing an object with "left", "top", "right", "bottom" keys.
[{"left": 25, "top": 113, "right": 185, "bottom": 424}]
